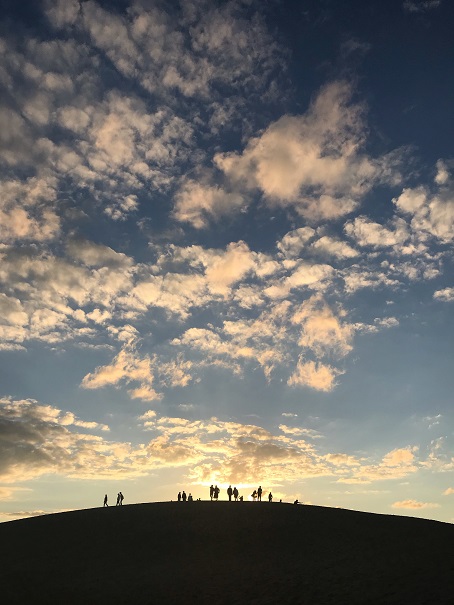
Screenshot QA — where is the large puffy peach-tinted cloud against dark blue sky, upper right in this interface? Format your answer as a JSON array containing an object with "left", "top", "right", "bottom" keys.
[{"left": 214, "top": 81, "right": 399, "bottom": 221}]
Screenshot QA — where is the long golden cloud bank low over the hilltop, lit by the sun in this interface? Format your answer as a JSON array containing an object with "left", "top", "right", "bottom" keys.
[{"left": 0, "top": 398, "right": 432, "bottom": 490}]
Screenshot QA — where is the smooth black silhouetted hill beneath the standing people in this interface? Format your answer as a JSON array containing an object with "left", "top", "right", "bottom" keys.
[{"left": 0, "top": 502, "right": 454, "bottom": 605}]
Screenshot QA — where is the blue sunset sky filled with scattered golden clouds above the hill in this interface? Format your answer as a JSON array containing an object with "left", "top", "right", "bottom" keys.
[{"left": 0, "top": 0, "right": 454, "bottom": 523}]
